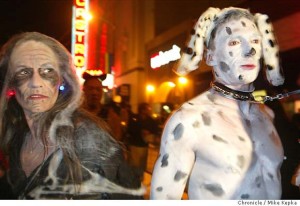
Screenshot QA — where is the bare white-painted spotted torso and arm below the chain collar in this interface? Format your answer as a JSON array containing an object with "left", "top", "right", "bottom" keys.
[{"left": 150, "top": 90, "right": 283, "bottom": 200}]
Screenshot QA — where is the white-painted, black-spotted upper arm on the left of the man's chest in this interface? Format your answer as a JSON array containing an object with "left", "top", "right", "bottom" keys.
[{"left": 150, "top": 111, "right": 195, "bottom": 199}]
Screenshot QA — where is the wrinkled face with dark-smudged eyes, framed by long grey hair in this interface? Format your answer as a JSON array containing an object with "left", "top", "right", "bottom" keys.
[{"left": 10, "top": 41, "right": 60, "bottom": 115}]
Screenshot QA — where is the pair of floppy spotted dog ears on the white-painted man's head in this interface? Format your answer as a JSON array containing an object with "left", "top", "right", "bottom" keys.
[{"left": 176, "top": 7, "right": 284, "bottom": 86}]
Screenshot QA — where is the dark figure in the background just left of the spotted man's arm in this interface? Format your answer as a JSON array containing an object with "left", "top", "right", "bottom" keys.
[{"left": 127, "top": 102, "right": 159, "bottom": 180}]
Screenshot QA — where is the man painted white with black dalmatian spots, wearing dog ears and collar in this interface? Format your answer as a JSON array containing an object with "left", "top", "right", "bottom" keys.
[{"left": 150, "top": 7, "right": 284, "bottom": 200}]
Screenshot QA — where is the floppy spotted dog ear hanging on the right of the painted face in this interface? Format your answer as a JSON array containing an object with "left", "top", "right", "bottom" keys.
[{"left": 255, "top": 13, "right": 284, "bottom": 86}]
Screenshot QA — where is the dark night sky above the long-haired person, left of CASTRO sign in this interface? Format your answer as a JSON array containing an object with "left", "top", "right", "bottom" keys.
[{"left": 0, "top": 0, "right": 73, "bottom": 49}]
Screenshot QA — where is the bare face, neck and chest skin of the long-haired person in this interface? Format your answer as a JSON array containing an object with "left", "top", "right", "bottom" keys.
[{"left": 9, "top": 41, "right": 61, "bottom": 176}]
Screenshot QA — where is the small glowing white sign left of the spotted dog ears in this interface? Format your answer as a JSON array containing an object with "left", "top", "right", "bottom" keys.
[{"left": 150, "top": 45, "right": 180, "bottom": 69}]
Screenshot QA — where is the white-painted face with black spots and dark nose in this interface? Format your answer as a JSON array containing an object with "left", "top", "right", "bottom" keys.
[{"left": 209, "top": 18, "right": 262, "bottom": 88}]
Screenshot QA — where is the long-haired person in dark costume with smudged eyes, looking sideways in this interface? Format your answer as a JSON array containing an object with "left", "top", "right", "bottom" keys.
[{"left": 0, "top": 32, "right": 144, "bottom": 199}]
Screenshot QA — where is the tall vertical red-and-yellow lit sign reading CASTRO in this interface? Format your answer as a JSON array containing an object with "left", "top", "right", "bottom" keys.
[{"left": 72, "top": 0, "right": 89, "bottom": 77}]
